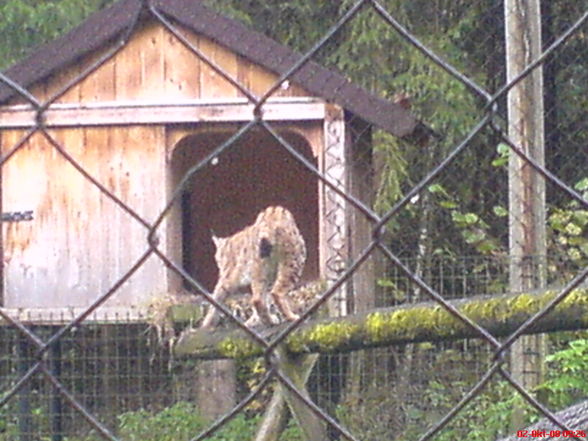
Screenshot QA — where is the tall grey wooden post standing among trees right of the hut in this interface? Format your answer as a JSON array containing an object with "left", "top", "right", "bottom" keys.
[{"left": 504, "top": 0, "right": 547, "bottom": 427}]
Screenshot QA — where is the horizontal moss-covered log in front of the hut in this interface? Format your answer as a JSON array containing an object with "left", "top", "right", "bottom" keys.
[{"left": 174, "top": 288, "right": 588, "bottom": 359}]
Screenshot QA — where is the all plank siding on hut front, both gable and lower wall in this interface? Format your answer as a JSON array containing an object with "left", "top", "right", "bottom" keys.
[{"left": 0, "top": 19, "right": 316, "bottom": 308}]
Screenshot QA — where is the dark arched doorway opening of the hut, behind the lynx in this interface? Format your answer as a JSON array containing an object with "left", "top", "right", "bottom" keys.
[{"left": 171, "top": 125, "right": 319, "bottom": 290}]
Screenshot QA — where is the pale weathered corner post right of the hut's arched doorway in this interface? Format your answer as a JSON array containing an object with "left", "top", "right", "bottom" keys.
[{"left": 320, "top": 113, "right": 375, "bottom": 316}]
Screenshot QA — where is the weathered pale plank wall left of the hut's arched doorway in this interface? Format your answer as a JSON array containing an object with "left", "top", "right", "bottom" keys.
[{"left": 2, "top": 127, "right": 166, "bottom": 308}]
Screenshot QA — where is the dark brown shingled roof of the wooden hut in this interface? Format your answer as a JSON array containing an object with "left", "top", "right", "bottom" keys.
[{"left": 0, "top": 0, "right": 424, "bottom": 137}]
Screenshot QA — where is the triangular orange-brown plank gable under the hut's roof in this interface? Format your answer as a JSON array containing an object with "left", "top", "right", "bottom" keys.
[{"left": 18, "top": 23, "right": 308, "bottom": 103}]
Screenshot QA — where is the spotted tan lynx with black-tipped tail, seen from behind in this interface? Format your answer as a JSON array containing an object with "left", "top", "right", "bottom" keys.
[{"left": 202, "top": 206, "right": 306, "bottom": 327}]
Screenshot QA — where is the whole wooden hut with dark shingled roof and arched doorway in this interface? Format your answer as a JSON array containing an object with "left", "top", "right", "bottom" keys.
[{"left": 0, "top": 0, "right": 420, "bottom": 322}]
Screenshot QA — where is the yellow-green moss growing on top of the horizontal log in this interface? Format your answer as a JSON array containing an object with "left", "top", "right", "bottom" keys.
[{"left": 176, "top": 288, "right": 588, "bottom": 358}]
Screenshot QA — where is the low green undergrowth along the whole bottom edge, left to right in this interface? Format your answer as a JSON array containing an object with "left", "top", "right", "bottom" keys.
[{"left": 0, "top": 332, "right": 576, "bottom": 441}]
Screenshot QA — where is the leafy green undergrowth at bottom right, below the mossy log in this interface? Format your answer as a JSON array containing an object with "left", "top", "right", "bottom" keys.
[{"left": 336, "top": 333, "right": 588, "bottom": 441}]
